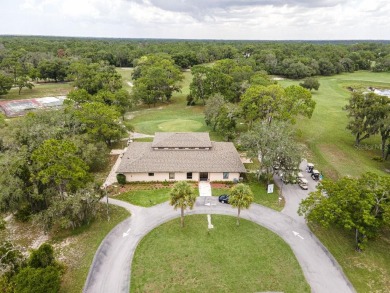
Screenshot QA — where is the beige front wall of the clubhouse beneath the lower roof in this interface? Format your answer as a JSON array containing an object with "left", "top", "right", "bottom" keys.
[{"left": 120, "top": 172, "right": 240, "bottom": 182}]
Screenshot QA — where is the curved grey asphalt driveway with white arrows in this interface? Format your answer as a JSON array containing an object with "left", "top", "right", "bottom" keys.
[{"left": 84, "top": 179, "right": 355, "bottom": 293}]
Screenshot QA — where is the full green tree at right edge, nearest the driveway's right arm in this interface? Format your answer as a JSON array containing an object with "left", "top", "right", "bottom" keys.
[{"left": 299, "top": 173, "right": 390, "bottom": 249}]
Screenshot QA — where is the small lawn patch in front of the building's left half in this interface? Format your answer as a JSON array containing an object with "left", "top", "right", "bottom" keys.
[{"left": 113, "top": 188, "right": 171, "bottom": 207}]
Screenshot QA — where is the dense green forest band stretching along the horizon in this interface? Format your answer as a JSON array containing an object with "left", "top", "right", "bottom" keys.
[{"left": 0, "top": 36, "right": 390, "bottom": 85}]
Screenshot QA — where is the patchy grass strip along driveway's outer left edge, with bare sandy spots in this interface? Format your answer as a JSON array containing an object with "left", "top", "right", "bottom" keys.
[{"left": 52, "top": 205, "right": 130, "bottom": 293}]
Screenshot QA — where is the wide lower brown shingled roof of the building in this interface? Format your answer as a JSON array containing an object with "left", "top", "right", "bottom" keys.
[{"left": 117, "top": 142, "right": 246, "bottom": 173}]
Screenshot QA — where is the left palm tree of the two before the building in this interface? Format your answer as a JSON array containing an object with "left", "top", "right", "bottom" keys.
[{"left": 169, "top": 181, "right": 196, "bottom": 227}]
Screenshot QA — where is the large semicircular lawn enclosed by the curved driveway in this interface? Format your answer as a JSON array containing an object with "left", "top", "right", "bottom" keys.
[{"left": 130, "top": 215, "right": 310, "bottom": 292}]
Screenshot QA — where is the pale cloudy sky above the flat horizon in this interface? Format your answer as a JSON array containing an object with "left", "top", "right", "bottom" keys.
[{"left": 0, "top": 0, "right": 390, "bottom": 40}]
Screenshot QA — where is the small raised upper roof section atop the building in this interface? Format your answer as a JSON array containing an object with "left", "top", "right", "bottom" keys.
[{"left": 152, "top": 132, "right": 212, "bottom": 148}]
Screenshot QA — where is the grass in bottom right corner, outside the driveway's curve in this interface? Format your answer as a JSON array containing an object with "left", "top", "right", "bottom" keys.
[{"left": 310, "top": 224, "right": 390, "bottom": 293}]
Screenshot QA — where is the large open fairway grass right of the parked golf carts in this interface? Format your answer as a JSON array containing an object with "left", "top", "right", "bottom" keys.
[{"left": 279, "top": 71, "right": 390, "bottom": 179}]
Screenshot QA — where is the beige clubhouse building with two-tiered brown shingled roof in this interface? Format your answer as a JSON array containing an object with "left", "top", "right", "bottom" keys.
[{"left": 116, "top": 132, "right": 246, "bottom": 182}]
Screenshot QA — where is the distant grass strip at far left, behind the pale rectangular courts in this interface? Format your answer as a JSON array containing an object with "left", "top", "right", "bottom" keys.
[{"left": 0, "top": 82, "right": 73, "bottom": 100}]
